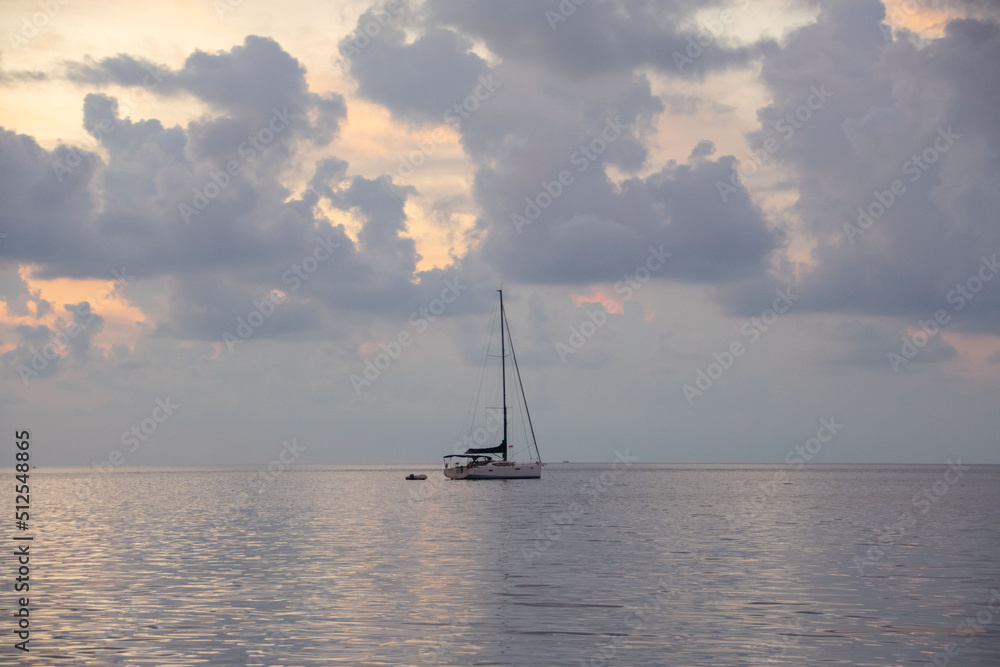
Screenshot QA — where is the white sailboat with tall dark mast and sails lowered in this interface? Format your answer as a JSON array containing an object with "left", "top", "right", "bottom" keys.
[{"left": 444, "top": 289, "right": 542, "bottom": 479}]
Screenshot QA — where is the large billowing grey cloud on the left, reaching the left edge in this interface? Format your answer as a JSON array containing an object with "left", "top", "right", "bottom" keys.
[{"left": 0, "top": 36, "right": 473, "bottom": 348}]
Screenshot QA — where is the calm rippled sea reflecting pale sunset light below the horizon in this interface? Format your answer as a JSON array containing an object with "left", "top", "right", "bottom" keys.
[{"left": 13, "top": 464, "right": 1000, "bottom": 667}]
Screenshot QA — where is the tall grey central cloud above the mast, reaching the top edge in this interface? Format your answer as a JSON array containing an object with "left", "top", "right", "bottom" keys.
[{"left": 341, "top": 1, "right": 783, "bottom": 290}]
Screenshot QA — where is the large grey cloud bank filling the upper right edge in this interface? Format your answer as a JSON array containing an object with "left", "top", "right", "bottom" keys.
[{"left": 724, "top": 0, "right": 1000, "bottom": 333}]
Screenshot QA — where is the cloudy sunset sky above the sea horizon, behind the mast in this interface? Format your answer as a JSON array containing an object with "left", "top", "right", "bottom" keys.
[{"left": 0, "top": 0, "right": 1000, "bottom": 470}]
